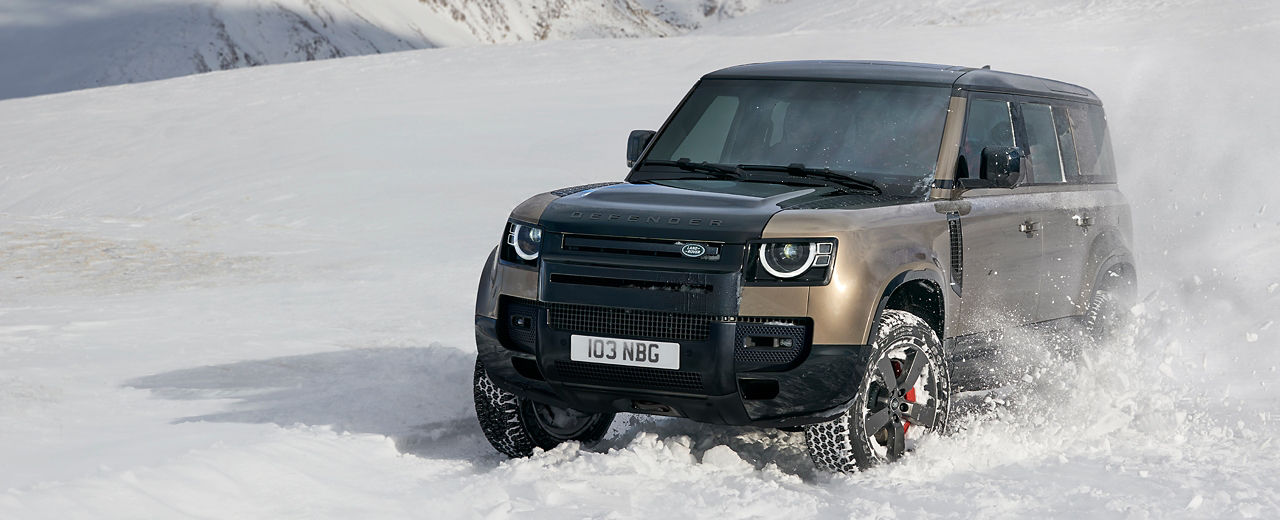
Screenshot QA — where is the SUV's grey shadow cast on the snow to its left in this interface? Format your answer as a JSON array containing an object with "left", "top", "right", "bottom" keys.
[{"left": 125, "top": 343, "right": 497, "bottom": 460}]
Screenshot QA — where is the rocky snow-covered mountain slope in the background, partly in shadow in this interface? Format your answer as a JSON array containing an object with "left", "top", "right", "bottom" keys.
[{"left": 0, "top": 0, "right": 767, "bottom": 99}]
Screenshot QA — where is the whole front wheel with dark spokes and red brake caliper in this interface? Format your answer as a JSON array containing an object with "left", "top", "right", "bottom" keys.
[{"left": 805, "top": 310, "right": 951, "bottom": 471}]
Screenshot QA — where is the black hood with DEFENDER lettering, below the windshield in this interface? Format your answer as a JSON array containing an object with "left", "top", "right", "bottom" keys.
[{"left": 539, "top": 181, "right": 808, "bottom": 243}]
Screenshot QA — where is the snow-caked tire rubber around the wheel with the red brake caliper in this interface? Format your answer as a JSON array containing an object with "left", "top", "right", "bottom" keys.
[{"left": 805, "top": 310, "right": 951, "bottom": 473}]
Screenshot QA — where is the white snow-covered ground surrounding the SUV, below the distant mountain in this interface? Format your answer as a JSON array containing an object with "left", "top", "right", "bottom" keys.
[{"left": 0, "top": 0, "right": 1280, "bottom": 519}]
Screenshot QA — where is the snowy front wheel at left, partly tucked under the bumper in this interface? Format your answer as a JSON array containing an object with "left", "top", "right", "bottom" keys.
[{"left": 472, "top": 359, "right": 613, "bottom": 457}]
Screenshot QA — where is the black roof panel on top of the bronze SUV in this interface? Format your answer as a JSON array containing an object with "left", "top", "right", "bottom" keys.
[{"left": 703, "top": 60, "right": 1100, "bottom": 102}]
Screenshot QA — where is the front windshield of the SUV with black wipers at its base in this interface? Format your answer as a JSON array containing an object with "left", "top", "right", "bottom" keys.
[{"left": 639, "top": 79, "right": 948, "bottom": 195}]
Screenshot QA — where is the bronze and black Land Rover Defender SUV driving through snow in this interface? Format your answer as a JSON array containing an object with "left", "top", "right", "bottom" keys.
[{"left": 475, "top": 61, "right": 1135, "bottom": 471}]
